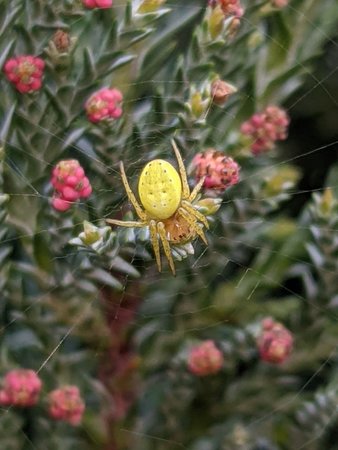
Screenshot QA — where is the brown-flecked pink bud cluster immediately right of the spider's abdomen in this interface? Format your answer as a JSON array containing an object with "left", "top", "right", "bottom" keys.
[{"left": 191, "top": 148, "right": 240, "bottom": 192}]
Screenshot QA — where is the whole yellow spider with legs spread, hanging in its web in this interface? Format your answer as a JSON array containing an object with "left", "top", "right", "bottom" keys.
[{"left": 106, "top": 141, "right": 209, "bottom": 275}]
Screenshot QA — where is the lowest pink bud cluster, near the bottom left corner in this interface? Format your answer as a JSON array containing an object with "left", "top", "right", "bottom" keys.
[{"left": 48, "top": 386, "right": 85, "bottom": 426}]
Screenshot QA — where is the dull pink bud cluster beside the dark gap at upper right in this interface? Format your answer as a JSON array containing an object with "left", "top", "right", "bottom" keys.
[{"left": 241, "top": 106, "right": 290, "bottom": 155}]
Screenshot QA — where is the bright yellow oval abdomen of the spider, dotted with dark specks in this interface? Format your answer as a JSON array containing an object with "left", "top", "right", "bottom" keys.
[{"left": 138, "top": 159, "right": 182, "bottom": 220}]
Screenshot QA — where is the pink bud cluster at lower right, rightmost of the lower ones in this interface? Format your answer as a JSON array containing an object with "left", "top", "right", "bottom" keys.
[{"left": 257, "top": 317, "right": 293, "bottom": 364}]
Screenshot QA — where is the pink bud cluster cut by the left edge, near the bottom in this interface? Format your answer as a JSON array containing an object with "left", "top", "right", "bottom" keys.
[{"left": 0, "top": 369, "right": 42, "bottom": 407}]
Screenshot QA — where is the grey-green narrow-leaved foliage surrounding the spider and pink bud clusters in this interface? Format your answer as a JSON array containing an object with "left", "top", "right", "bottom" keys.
[{"left": 0, "top": 0, "right": 338, "bottom": 450}]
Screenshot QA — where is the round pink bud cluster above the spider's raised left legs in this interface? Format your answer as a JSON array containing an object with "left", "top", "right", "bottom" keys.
[{"left": 85, "top": 88, "right": 123, "bottom": 123}]
